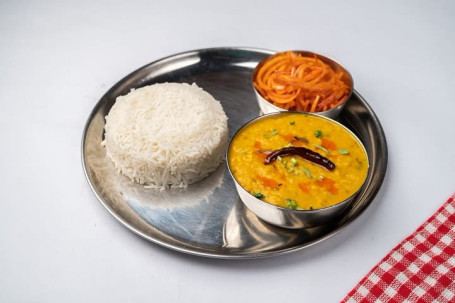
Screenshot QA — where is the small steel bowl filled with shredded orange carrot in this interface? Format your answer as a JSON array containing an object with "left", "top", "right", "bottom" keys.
[{"left": 253, "top": 51, "right": 354, "bottom": 118}]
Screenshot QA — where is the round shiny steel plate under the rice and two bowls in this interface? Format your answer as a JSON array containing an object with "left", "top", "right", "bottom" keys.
[{"left": 82, "top": 48, "right": 388, "bottom": 259}]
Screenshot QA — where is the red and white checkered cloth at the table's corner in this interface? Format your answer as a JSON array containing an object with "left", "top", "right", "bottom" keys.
[{"left": 342, "top": 194, "right": 455, "bottom": 303}]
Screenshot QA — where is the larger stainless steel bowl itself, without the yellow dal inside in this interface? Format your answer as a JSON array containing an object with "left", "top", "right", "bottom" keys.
[{"left": 226, "top": 111, "right": 369, "bottom": 229}]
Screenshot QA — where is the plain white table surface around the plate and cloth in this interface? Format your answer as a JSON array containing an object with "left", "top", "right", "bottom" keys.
[{"left": 0, "top": 0, "right": 455, "bottom": 302}]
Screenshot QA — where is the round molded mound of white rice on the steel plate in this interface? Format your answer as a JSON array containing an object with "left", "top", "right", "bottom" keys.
[{"left": 103, "top": 83, "right": 228, "bottom": 188}]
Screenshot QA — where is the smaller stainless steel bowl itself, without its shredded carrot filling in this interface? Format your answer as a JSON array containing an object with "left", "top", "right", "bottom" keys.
[{"left": 252, "top": 51, "right": 354, "bottom": 119}]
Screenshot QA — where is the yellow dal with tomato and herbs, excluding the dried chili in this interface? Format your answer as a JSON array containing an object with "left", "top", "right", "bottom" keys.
[{"left": 228, "top": 113, "right": 369, "bottom": 209}]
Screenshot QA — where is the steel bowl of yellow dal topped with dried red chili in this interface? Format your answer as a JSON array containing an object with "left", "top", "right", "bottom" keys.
[{"left": 226, "top": 111, "right": 369, "bottom": 229}]
